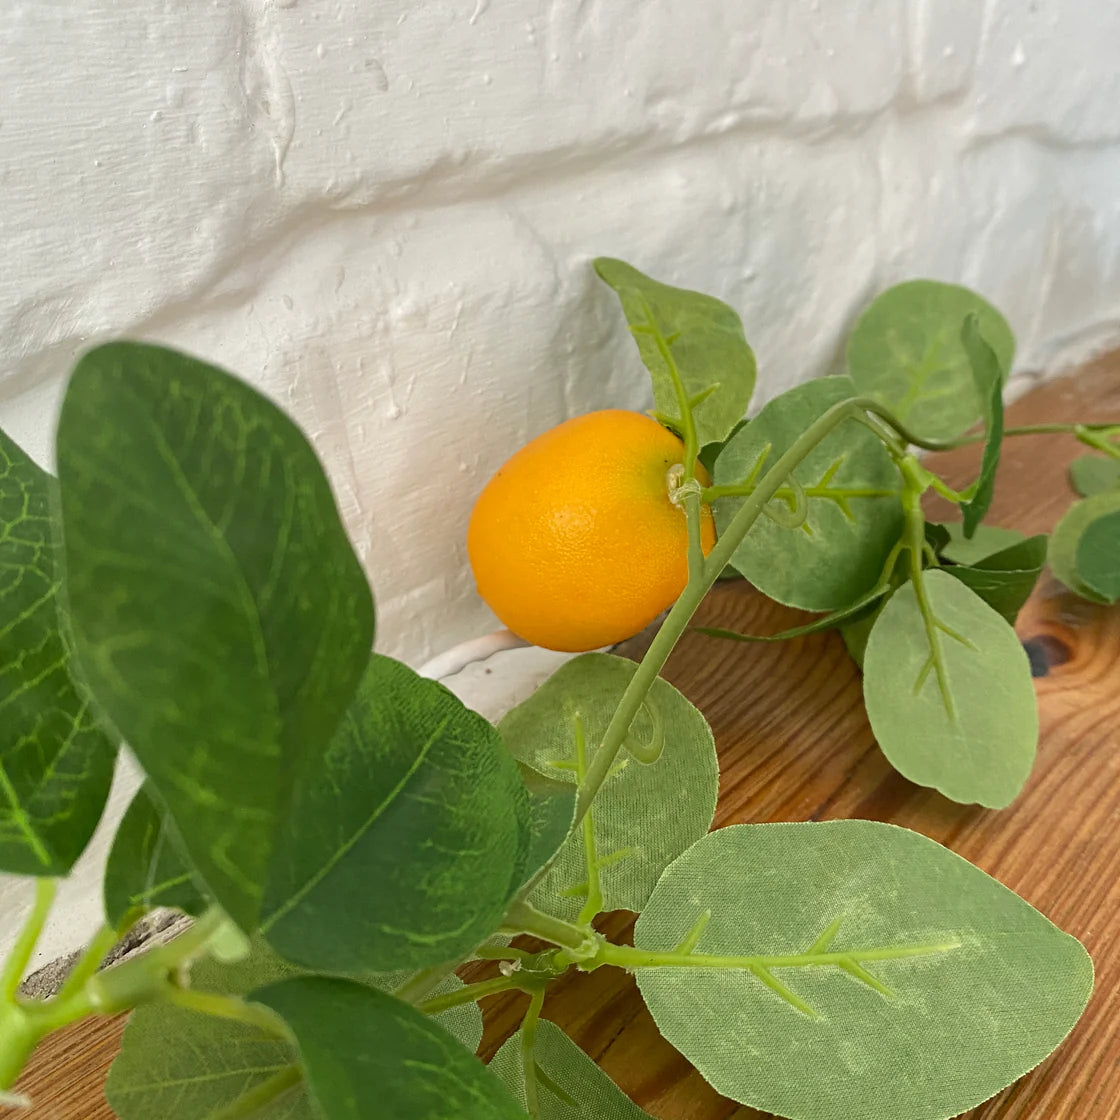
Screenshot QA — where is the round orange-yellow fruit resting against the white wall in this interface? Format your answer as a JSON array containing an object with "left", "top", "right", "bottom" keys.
[{"left": 467, "top": 409, "right": 716, "bottom": 652}]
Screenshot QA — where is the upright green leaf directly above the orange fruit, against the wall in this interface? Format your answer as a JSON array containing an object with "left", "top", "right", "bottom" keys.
[{"left": 595, "top": 256, "right": 756, "bottom": 445}]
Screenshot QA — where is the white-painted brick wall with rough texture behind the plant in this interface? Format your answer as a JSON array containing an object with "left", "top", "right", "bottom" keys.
[{"left": 0, "top": 0, "right": 1120, "bottom": 963}]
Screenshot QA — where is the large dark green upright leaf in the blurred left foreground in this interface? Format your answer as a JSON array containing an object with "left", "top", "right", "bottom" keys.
[{"left": 58, "top": 343, "right": 373, "bottom": 931}]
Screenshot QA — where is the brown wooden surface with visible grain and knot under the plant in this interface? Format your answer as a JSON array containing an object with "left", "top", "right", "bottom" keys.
[{"left": 13, "top": 353, "right": 1120, "bottom": 1120}]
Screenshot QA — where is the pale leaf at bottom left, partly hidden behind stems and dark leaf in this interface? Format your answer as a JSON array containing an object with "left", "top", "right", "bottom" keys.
[{"left": 105, "top": 942, "right": 483, "bottom": 1120}]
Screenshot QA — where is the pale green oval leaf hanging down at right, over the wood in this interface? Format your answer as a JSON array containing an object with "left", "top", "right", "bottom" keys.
[{"left": 864, "top": 570, "right": 1038, "bottom": 809}]
